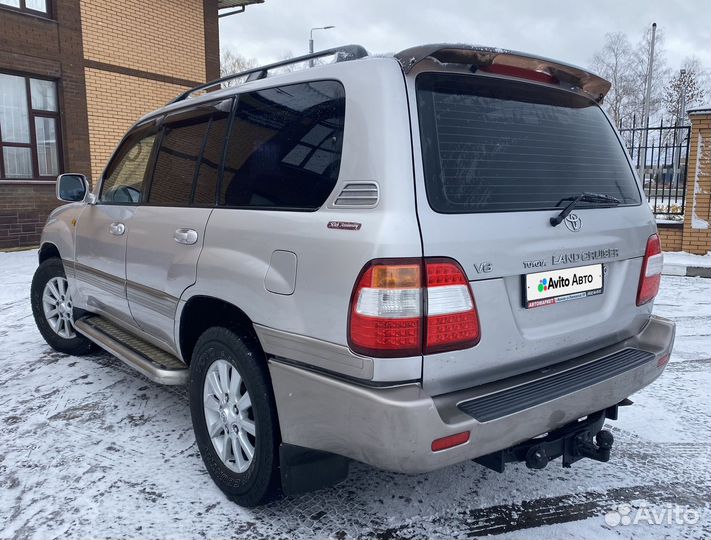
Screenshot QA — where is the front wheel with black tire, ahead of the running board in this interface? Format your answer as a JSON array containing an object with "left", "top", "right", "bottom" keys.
[{"left": 30, "top": 258, "right": 93, "bottom": 356}]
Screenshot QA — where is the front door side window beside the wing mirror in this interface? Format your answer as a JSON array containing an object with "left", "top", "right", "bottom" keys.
[{"left": 99, "top": 131, "right": 156, "bottom": 204}]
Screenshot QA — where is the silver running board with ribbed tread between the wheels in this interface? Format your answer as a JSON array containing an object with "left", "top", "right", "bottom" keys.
[{"left": 74, "top": 315, "right": 189, "bottom": 384}]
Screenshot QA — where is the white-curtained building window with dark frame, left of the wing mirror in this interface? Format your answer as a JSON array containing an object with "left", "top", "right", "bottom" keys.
[{"left": 0, "top": 71, "right": 60, "bottom": 180}]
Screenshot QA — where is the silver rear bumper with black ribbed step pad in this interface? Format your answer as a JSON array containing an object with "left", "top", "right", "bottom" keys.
[{"left": 269, "top": 316, "right": 675, "bottom": 473}]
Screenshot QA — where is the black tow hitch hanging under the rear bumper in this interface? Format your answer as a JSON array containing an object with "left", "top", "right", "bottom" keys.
[{"left": 474, "top": 399, "right": 632, "bottom": 472}]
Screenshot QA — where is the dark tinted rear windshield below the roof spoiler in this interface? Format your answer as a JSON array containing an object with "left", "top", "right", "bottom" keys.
[{"left": 416, "top": 73, "right": 640, "bottom": 214}]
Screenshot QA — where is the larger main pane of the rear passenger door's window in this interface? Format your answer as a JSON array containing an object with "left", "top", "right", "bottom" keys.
[{"left": 148, "top": 116, "right": 210, "bottom": 206}]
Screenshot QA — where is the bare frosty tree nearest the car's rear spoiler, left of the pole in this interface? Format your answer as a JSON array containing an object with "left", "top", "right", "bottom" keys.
[{"left": 592, "top": 32, "right": 636, "bottom": 126}]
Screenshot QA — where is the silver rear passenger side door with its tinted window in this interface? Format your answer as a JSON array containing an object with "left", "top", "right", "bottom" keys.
[{"left": 126, "top": 99, "right": 232, "bottom": 348}]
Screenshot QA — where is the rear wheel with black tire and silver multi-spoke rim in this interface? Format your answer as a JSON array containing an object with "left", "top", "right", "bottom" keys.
[{"left": 189, "top": 327, "right": 280, "bottom": 507}]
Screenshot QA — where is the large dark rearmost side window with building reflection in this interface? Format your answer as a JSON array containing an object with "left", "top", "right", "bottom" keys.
[{"left": 220, "top": 81, "right": 345, "bottom": 210}]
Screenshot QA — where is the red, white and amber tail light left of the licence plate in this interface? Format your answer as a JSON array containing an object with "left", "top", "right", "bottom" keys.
[{"left": 348, "top": 258, "right": 479, "bottom": 357}]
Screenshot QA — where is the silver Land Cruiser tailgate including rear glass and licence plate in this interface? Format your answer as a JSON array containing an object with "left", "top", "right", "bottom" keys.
[{"left": 408, "top": 72, "right": 654, "bottom": 393}]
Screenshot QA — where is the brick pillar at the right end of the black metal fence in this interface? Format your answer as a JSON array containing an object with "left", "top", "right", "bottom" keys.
[{"left": 682, "top": 109, "right": 711, "bottom": 255}]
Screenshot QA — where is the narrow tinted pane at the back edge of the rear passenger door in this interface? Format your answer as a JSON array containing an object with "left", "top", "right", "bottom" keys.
[{"left": 193, "top": 100, "right": 232, "bottom": 206}]
